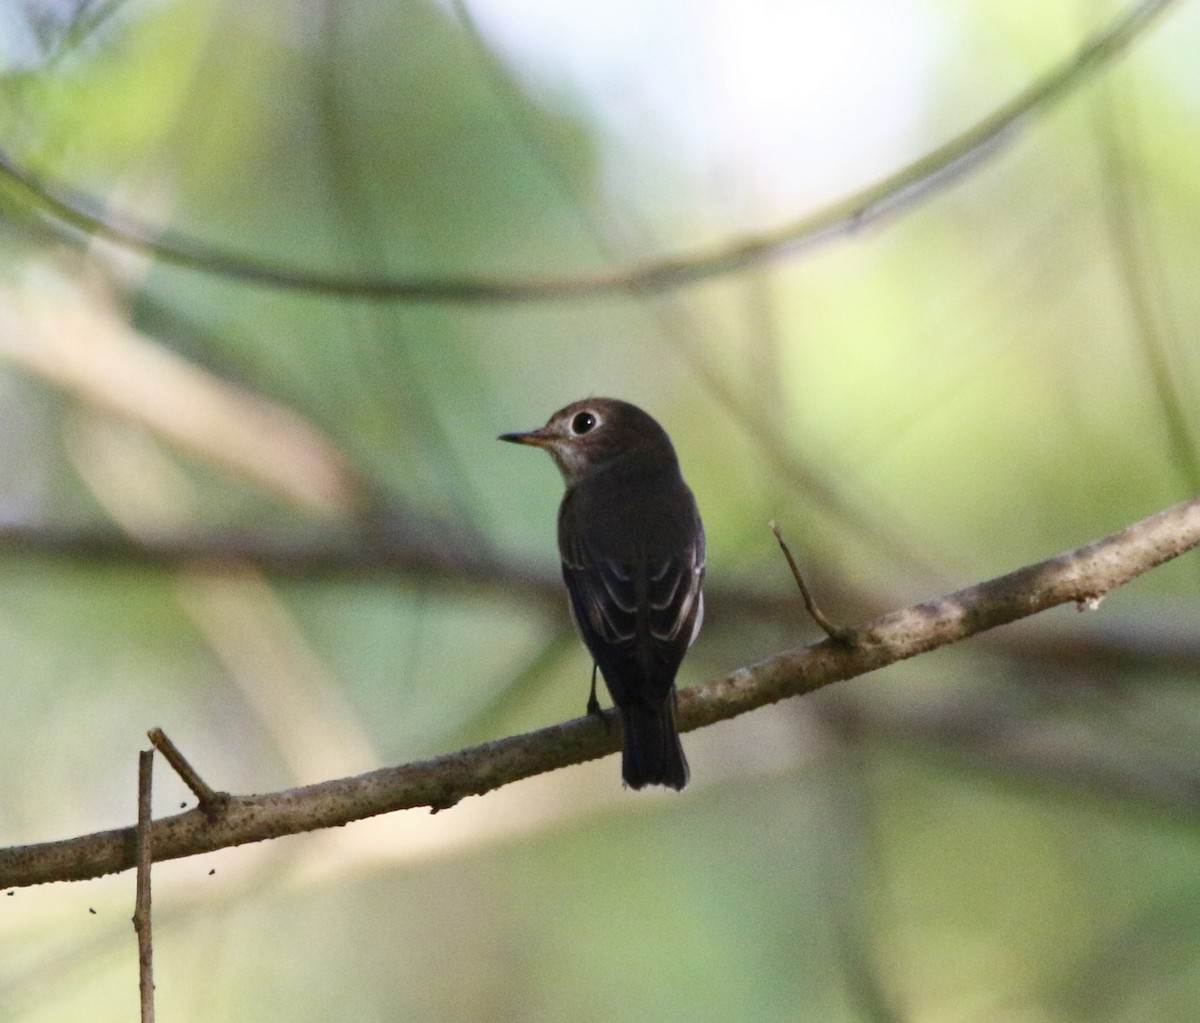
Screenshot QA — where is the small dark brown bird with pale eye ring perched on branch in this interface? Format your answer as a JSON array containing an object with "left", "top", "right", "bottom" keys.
[{"left": 499, "top": 397, "right": 704, "bottom": 789}]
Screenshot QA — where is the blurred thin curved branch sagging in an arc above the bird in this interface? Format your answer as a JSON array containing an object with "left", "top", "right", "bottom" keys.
[{"left": 0, "top": 0, "right": 1177, "bottom": 303}]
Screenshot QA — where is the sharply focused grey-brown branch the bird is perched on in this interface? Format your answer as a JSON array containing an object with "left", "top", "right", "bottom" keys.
[{"left": 0, "top": 498, "right": 1200, "bottom": 889}]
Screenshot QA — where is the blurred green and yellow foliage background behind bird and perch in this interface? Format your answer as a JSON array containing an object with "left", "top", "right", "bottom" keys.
[{"left": 0, "top": 0, "right": 1200, "bottom": 1023}]
